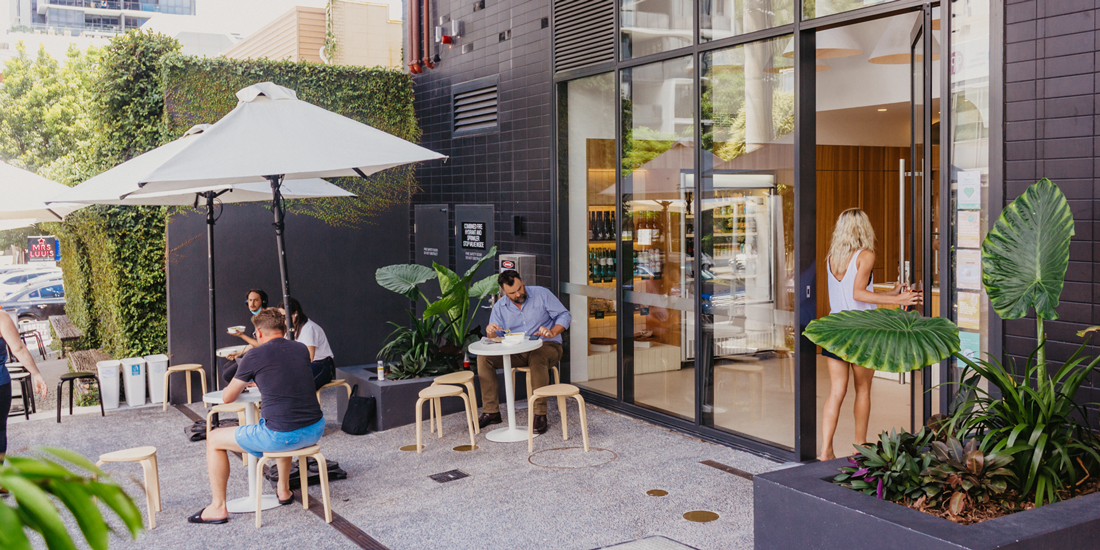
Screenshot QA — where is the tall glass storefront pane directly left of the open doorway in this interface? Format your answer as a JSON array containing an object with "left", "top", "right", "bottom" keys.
[{"left": 691, "top": 36, "right": 795, "bottom": 448}]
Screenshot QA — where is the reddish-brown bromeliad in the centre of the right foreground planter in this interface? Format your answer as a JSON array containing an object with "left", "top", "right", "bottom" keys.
[{"left": 915, "top": 438, "right": 1015, "bottom": 516}]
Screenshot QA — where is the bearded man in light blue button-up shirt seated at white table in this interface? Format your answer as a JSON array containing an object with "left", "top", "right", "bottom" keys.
[{"left": 477, "top": 270, "right": 573, "bottom": 433}]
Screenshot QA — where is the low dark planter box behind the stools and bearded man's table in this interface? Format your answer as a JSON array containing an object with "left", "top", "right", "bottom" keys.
[{"left": 337, "top": 365, "right": 527, "bottom": 431}]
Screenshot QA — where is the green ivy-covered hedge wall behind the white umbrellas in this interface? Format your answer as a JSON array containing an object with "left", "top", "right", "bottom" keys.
[{"left": 57, "top": 31, "right": 420, "bottom": 358}]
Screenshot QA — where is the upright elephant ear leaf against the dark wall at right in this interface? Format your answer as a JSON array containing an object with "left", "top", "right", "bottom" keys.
[{"left": 981, "top": 178, "right": 1074, "bottom": 319}]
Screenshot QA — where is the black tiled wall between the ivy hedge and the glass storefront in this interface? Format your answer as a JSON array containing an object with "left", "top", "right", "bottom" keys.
[{"left": 405, "top": 0, "right": 552, "bottom": 286}]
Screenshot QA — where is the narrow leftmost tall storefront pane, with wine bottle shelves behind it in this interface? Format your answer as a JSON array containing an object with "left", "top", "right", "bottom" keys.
[{"left": 558, "top": 73, "right": 623, "bottom": 397}]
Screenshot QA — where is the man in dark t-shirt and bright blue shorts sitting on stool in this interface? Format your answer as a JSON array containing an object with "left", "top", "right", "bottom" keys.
[{"left": 188, "top": 308, "right": 325, "bottom": 524}]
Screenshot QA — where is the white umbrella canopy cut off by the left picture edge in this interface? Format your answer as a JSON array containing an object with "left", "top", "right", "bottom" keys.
[{"left": 0, "top": 163, "right": 81, "bottom": 224}]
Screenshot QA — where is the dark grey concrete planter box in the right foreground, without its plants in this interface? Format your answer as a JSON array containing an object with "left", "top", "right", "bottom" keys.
[{"left": 752, "top": 459, "right": 1100, "bottom": 550}]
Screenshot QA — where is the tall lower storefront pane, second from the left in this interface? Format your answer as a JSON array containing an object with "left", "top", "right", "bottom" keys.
[{"left": 620, "top": 57, "right": 695, "bottom": 419}]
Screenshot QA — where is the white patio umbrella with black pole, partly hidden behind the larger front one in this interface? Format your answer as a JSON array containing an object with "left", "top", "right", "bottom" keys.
[{"left": 51, "top": 124, "right": 354, "bottom": 391}]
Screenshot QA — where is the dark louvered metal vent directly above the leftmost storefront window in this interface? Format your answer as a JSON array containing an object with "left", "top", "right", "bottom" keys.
[{"left": 553, "top": 0, "right": 615, "bottom": 73}]
